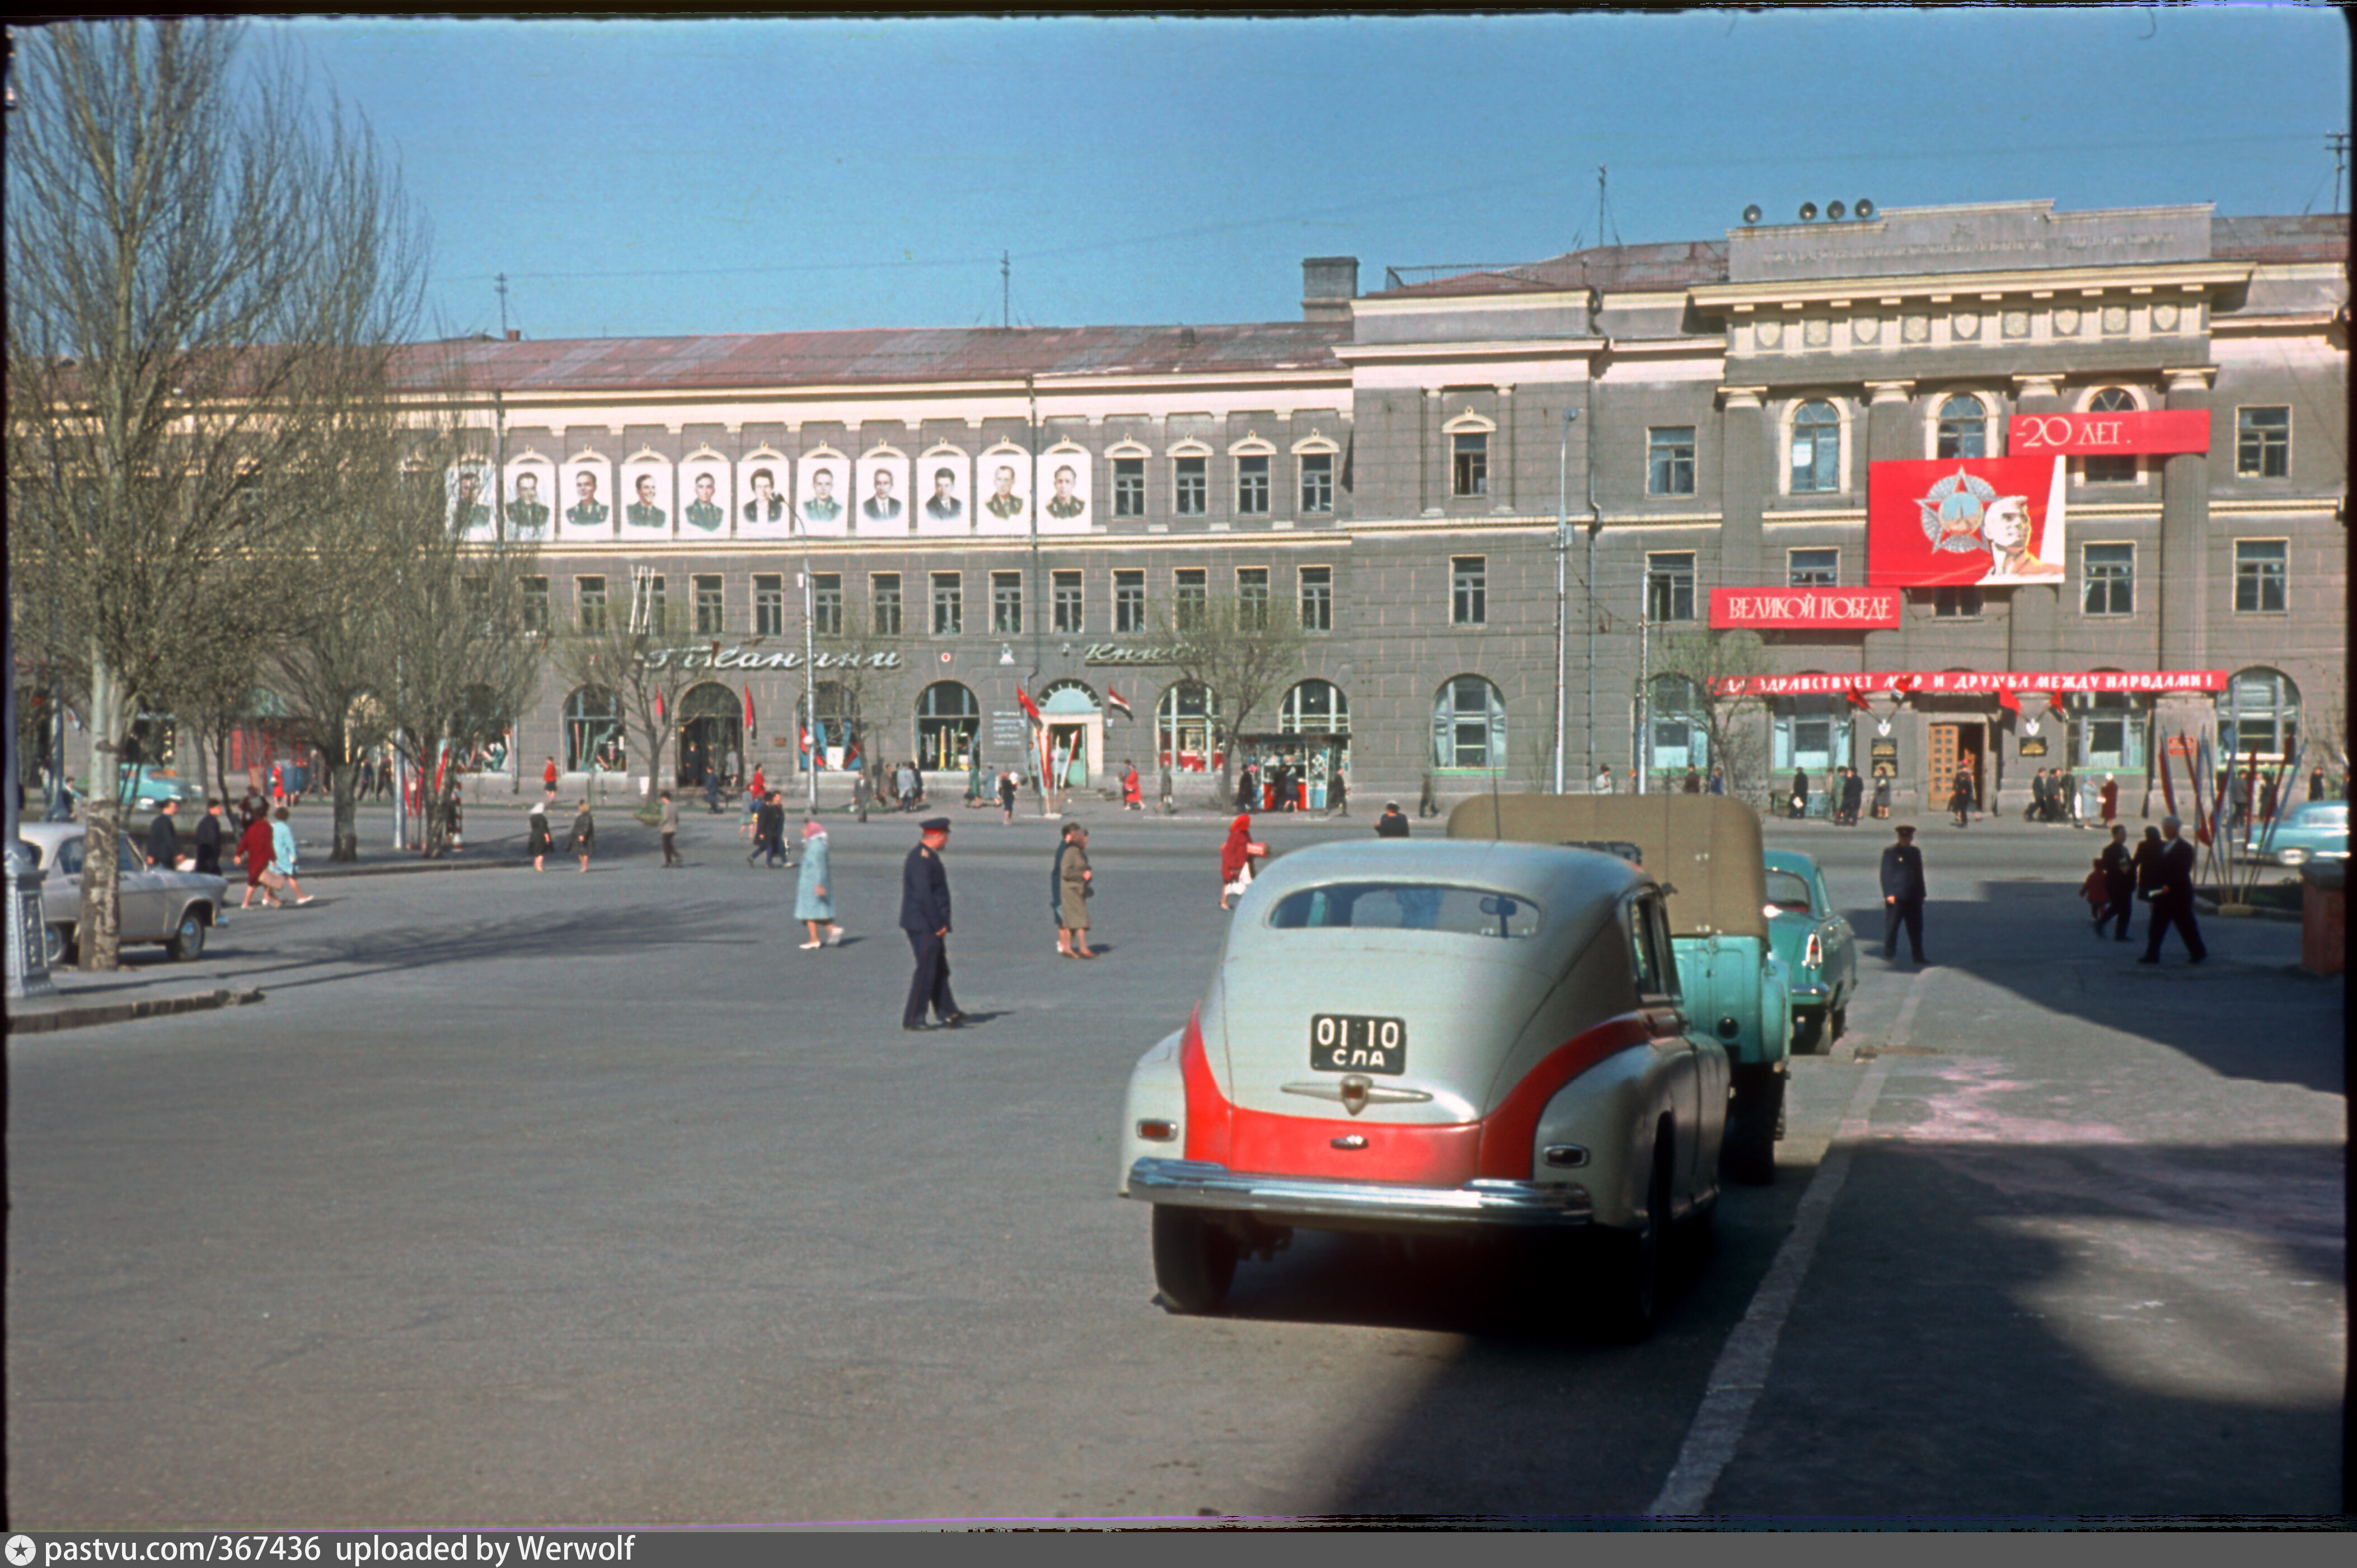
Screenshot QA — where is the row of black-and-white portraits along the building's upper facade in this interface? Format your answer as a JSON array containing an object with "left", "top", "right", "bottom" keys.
[{"left": 443, "top": 448, "right": 1094, "bottom": 542}]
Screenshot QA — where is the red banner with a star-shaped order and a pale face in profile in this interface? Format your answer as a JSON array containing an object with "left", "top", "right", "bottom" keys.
[{"left": 1867, "top": 457, "right": 2063, "bottom": 587}]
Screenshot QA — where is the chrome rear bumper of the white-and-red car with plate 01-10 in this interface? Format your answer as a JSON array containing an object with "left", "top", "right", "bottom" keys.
[{"left": 1129, "top": 1158, "right": 1596, "bottom": 1228}]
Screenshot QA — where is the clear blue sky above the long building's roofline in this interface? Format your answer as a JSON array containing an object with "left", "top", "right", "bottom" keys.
[{"left": 255, "top": 4, "right": 2350, "bottom": 337}]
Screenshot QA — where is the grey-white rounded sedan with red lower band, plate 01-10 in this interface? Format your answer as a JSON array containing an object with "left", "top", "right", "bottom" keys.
[{"left": 1119, "top": 842, "right": 1728, "bottom": 1335}]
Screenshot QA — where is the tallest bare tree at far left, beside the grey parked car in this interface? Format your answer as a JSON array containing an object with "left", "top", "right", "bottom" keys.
[{"left": 7, "top": 21, "right": 422, "bottom": 969}]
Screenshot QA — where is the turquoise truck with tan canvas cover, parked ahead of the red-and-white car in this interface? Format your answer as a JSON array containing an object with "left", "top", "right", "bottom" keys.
[{"left": 1450, "top": 795, "right": 1791, "bottom": 1184}]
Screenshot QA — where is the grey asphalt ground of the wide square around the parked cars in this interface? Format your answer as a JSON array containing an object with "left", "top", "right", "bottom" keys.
[{"left": 7, "top": 811, "right": 2347, "bottom": 1528}]
